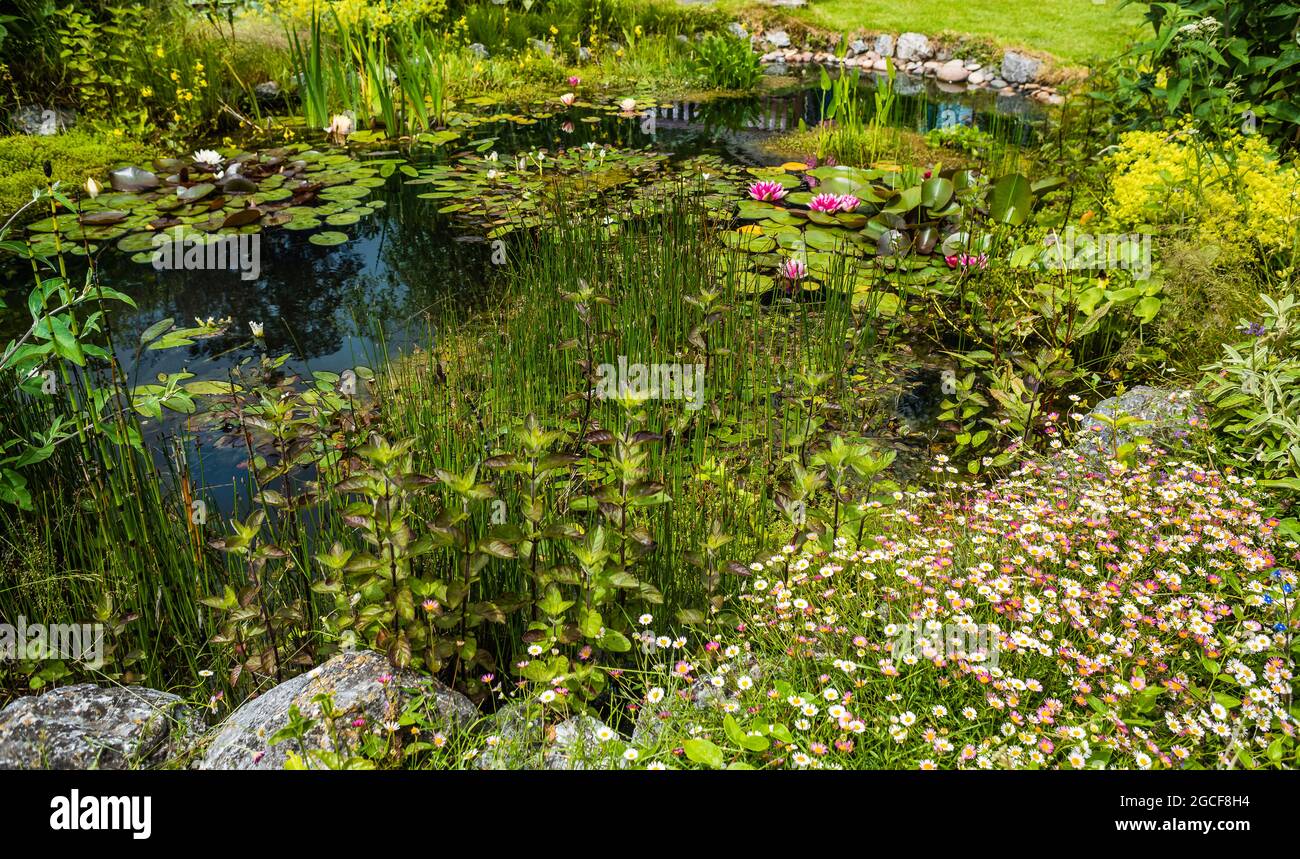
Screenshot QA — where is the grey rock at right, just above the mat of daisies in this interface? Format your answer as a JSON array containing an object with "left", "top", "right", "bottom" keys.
[{"left": 1074, "top": 385, "right": 1205, "bottom": 457}]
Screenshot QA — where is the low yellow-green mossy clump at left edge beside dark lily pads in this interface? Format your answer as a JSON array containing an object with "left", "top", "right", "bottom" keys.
[{"left": 0, "top": 130, "right": 152, "bottom": 218}]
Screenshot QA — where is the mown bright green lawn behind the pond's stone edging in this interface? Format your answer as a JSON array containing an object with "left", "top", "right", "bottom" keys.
[{"left": 722, "top": 0, "right": 1143, "bottom": 64}]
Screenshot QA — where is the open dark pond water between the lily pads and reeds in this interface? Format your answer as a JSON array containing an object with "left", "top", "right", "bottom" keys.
[{"left": 5, "top": 75, "right": 1041, "bottom": 508}]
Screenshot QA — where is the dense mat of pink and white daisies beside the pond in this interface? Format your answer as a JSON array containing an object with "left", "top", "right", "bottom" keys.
[{"left": 493, "top": 455, "right": 1297, "bottom": 769}]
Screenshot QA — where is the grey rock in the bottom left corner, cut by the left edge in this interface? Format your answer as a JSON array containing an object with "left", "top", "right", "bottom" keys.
[{"left": 0, "top": 684, "right": 203, "bottom": 769}]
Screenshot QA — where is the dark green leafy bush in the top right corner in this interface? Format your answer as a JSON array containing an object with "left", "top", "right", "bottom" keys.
[{"left": 1117, "top": 0, "right": 1300, "bottom": 146}]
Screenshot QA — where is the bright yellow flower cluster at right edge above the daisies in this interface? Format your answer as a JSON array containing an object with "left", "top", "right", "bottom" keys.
[{"left": 1109, "top": 127, "right": 1300, "bottom": 256}]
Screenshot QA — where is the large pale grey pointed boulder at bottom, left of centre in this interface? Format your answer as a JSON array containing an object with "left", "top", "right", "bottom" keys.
[{"left": 196, "top": 650, "right": 478, "bottom": 769}]
